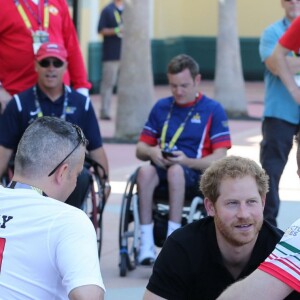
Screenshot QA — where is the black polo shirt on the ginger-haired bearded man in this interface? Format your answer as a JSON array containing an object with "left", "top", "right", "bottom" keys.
[{"left": 147, "top": 217, "right": 297, "bottom": 300}]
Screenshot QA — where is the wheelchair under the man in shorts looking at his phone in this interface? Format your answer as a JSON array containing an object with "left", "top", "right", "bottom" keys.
[{"left": 119, "top": 168, "right": 207, "bottom": 277}]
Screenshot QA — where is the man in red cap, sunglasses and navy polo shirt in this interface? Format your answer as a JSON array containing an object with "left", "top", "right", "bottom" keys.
[{"left": 0, "top": 43, "right": 108, "bottom": 208}]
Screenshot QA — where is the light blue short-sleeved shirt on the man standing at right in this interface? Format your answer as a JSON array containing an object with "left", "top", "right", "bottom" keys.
[{"left": 259, "top": 18, "right": 300, "bottom": 125}]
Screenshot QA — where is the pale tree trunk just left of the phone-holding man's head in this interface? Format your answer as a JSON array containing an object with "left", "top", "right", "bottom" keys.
[{"left": 115, "top": 0, "right": 154, "bottom": 141}]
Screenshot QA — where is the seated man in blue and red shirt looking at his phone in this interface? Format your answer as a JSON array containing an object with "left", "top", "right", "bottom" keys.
[{"left": 136, "top": 54, "right": 231, "bottom": 265}]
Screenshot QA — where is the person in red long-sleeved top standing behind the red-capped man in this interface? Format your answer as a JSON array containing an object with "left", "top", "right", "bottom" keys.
[{"left": 0, "top": 0, "right": 91, "bottom": 110}]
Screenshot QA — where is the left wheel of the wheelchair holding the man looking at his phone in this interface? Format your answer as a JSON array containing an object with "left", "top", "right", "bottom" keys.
[{"left": 119, "top": 172, "right": 138, "bottom": 277}]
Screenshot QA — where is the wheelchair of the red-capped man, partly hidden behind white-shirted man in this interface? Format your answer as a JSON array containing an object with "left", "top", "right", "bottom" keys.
[{"left": 1, "top": 155, "right": 107, "bottom": 259}]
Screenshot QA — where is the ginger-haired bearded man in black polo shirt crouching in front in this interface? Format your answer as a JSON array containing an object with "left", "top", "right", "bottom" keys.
[{"left": 144, "top": 156, "right": 296, "bottom": 300}]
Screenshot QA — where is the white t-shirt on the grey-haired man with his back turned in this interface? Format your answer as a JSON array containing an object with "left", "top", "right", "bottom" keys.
[{"left": 0, "top": 186, "right": 105, "bottom": 300}]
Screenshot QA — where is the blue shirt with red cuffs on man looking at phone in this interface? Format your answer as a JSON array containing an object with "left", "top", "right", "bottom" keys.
[{"left": 140, "top": 95, "right": 231, "bottom": 158}]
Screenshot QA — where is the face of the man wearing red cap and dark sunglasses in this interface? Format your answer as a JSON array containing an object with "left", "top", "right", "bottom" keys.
[{"left": 35, "top": 57, "right": 67, "bottom": 91}]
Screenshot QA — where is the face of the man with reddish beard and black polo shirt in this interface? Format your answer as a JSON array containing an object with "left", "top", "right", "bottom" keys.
[{"left": 205, "top": 175, "right": 265, "bottom": 247}]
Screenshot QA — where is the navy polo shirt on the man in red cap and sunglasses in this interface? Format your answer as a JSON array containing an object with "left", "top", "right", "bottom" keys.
[{"left": 0, "top": 86, "right": 102, "bottom": 151}]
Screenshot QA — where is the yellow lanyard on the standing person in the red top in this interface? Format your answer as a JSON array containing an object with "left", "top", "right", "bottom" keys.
[{"left": 14, "top": 0, "right": 49, "bottom": 31}]
